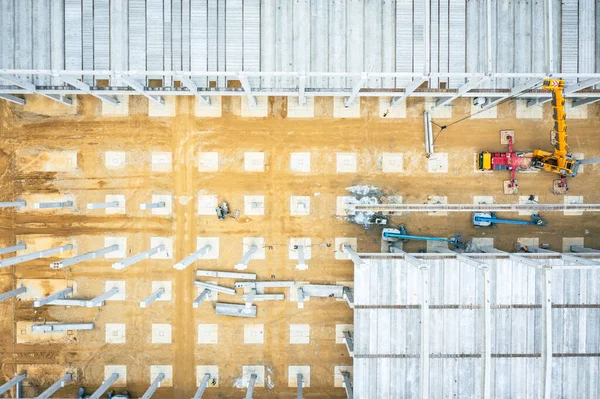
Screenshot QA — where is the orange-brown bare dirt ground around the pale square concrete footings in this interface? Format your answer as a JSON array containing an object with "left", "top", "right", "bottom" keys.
[{"left": 0, "top": 93, "right": 600, "bottom": 399}]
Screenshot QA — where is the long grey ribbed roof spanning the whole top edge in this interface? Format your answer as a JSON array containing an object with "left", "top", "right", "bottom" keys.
[{"left": 0, "top": 0, "right": 600, "bottom": 106}]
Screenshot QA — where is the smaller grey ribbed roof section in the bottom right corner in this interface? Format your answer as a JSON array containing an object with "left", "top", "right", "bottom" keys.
[{"left": 353, "top": 253, "right": 600, "bottom": 398}]
